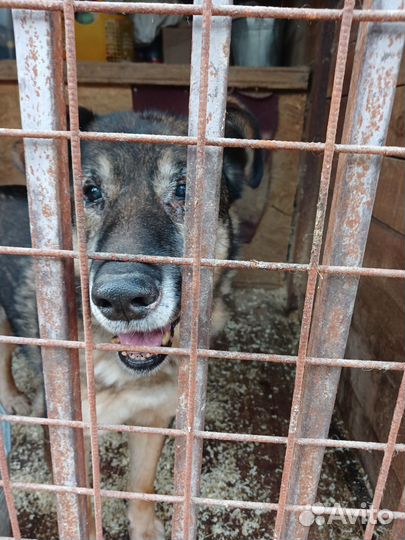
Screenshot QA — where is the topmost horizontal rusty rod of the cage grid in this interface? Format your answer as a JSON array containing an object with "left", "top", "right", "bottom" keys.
[{"left": 0, "top": 0, "right": 405, "bottom": 22}]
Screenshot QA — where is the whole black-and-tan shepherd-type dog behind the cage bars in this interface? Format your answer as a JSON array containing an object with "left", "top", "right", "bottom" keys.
[{"left": 0, "top": 103, "right": 263, "bottom": 540}]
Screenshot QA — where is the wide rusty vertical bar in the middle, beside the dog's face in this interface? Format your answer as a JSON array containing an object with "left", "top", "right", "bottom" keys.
[{"left": 172, "top": 0, "right": 232, "bottom": 540}]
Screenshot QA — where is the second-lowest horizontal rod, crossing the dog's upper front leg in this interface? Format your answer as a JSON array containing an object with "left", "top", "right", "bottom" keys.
[{"left": 0, "top": 414, "right": 405, "bottom": 452}]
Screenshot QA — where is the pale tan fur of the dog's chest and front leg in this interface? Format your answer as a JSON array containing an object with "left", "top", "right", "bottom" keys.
[{"left": 81, "top": 299, "right": 226, "bottom": 540}]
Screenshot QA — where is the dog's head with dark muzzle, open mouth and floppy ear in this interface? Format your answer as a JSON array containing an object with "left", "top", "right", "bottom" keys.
[{"left": 76, "top": 105, "right": 262, "bottom": 375}]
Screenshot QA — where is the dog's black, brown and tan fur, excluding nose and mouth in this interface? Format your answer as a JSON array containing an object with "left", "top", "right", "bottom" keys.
[{"left": 0, "top": 105, "right": 257, "bottom": 540}]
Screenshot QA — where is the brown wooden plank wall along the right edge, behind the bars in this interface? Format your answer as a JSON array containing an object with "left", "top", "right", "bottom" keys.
[{"left": 338, "top": 46, "right": 405, "bottom": 510}]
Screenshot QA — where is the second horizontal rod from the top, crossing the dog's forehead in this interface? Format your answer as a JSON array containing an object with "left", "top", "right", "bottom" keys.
[{"left": 0, "top": 128, "right": 405, "bottom": 158}]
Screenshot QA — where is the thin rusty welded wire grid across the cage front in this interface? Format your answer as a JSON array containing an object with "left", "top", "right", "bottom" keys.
[{"left": 0, "top": 0, "right": 405, "bottom": 540}]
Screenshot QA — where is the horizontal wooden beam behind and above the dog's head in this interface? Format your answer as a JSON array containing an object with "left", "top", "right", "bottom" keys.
[{"left": 0, "top": 60, "right": 309, "bottom": 91}]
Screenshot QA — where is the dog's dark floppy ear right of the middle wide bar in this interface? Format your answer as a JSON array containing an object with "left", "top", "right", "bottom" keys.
[{"left": 224, "top": 99, "right": 263, "bottom": 201}]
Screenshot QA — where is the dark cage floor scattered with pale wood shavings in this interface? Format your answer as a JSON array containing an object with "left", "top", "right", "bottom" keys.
[{"left": 10, "top": 289, "right": 384, "bottom": 540}]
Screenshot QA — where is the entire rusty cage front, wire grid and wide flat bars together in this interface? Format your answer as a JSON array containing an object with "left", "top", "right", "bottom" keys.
[{"left": 0, "top": 0, "right": 405, "bottom": 540}]
